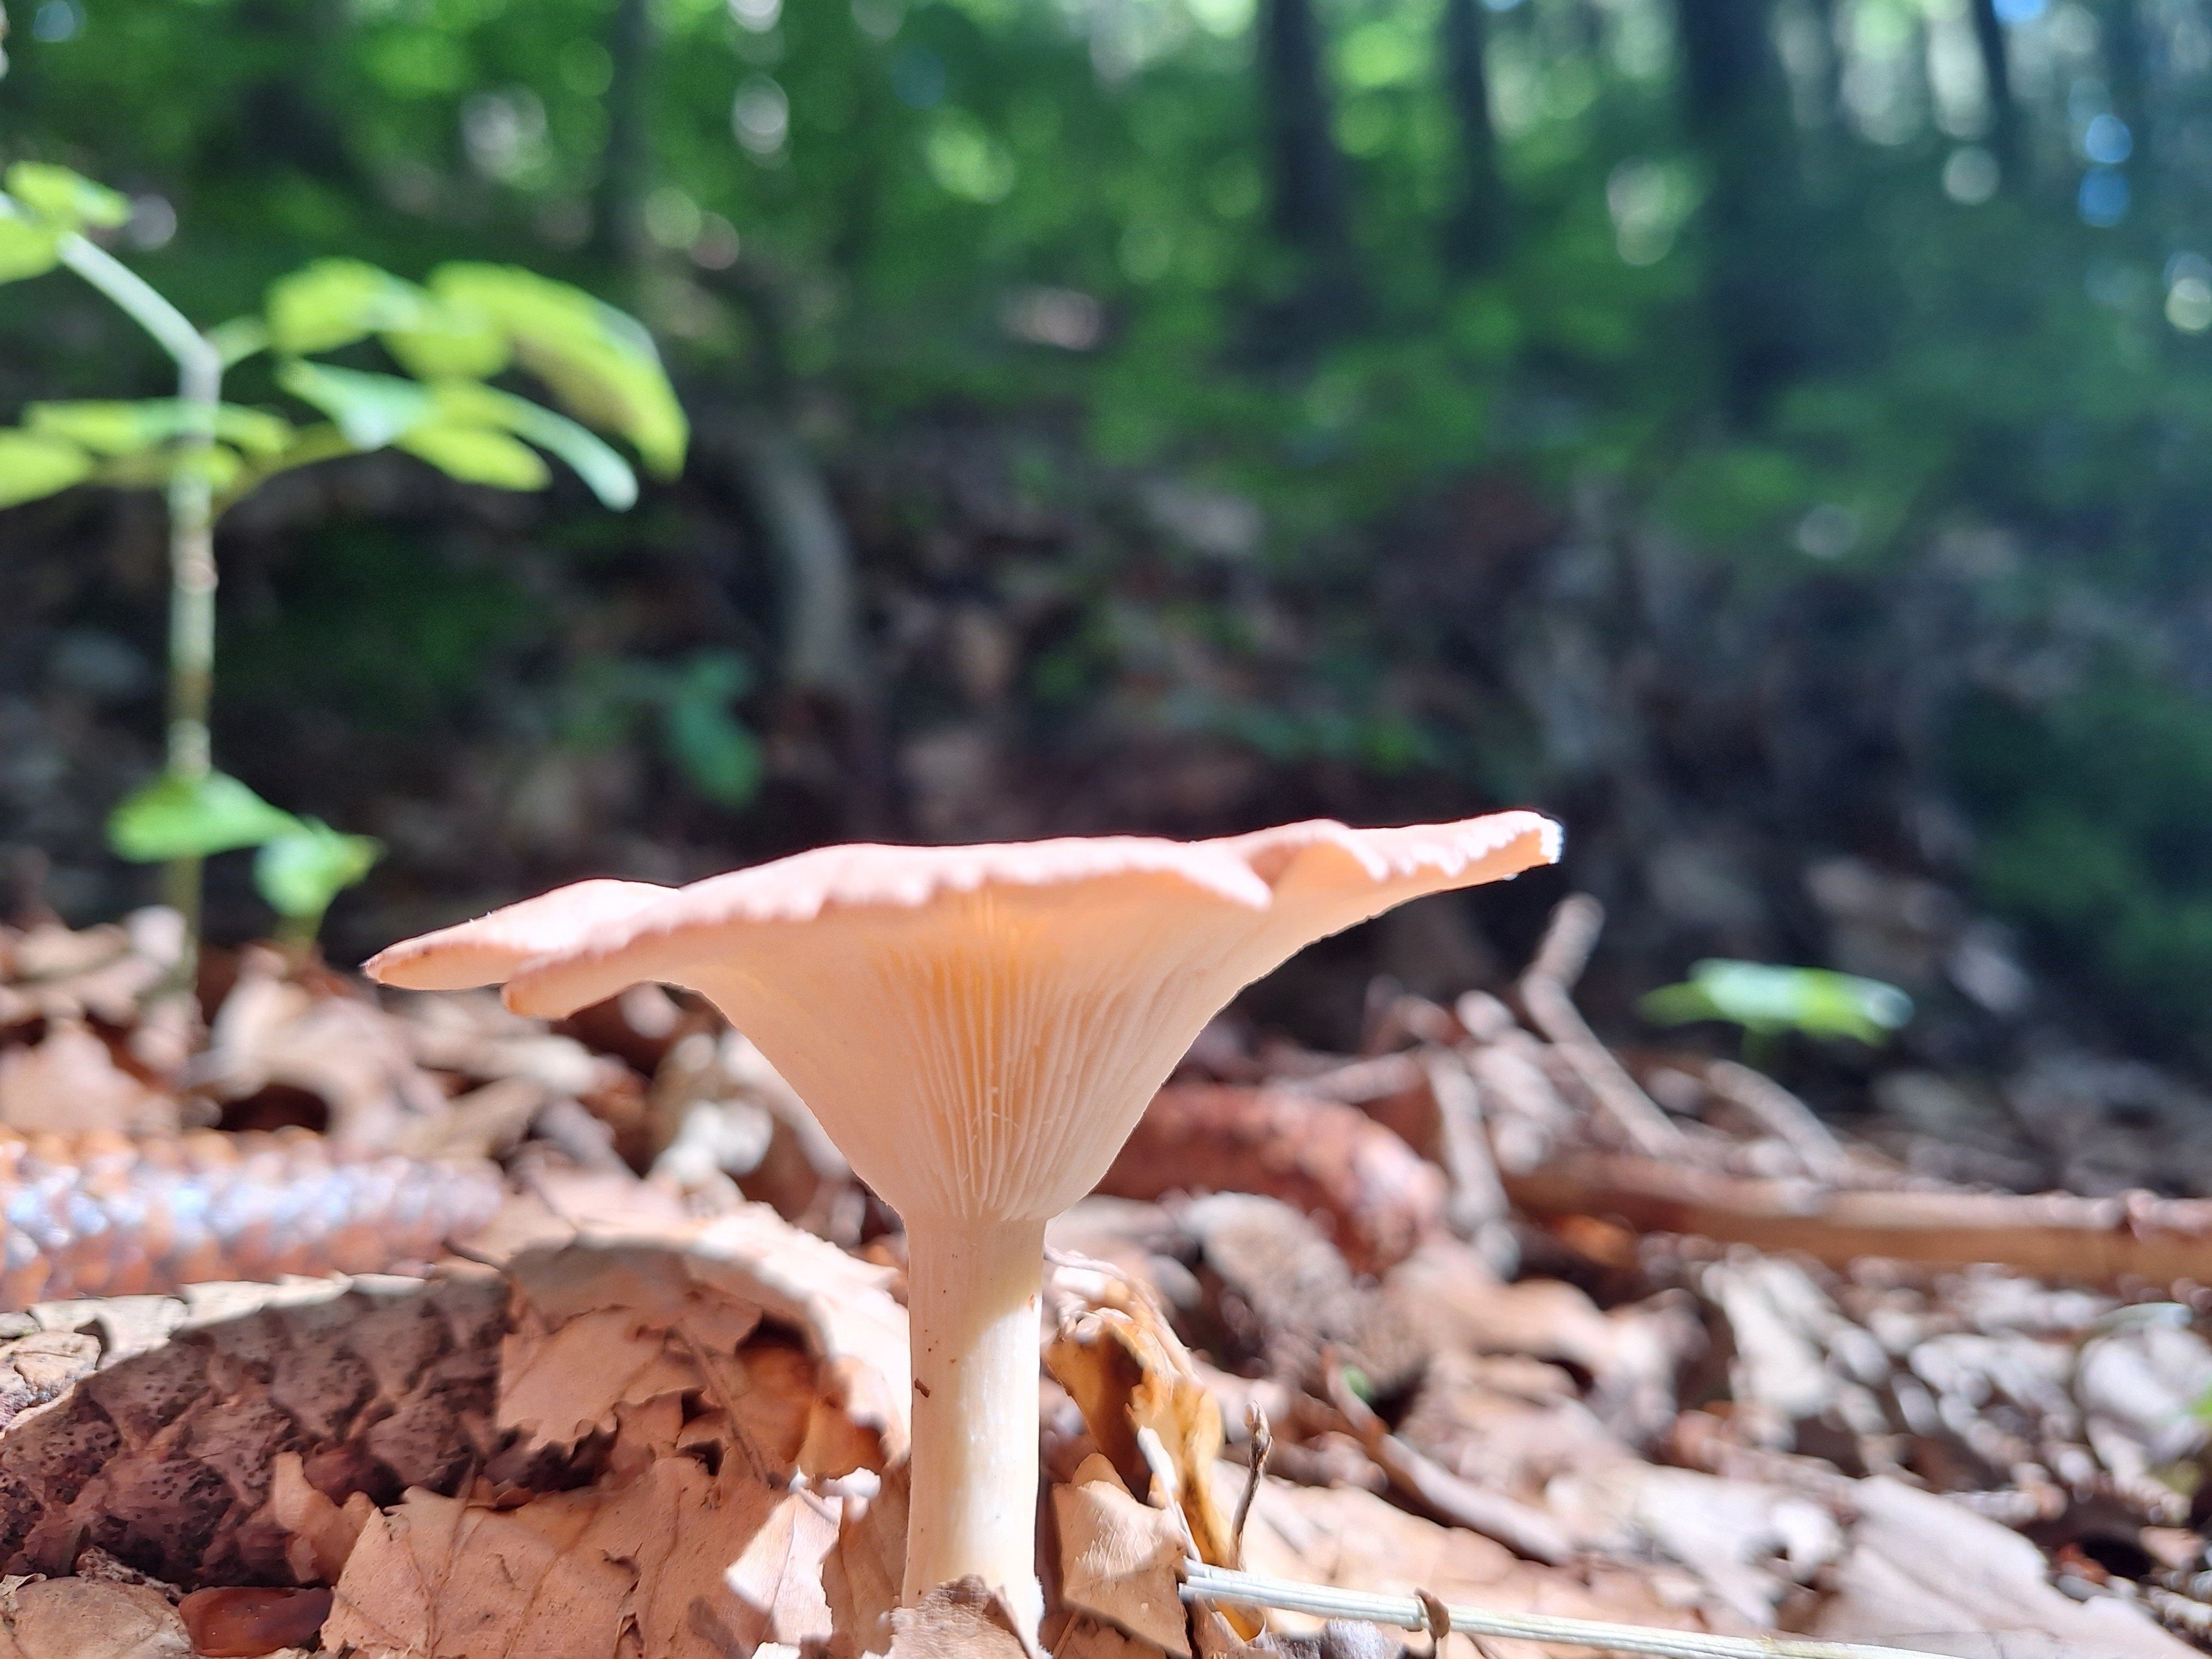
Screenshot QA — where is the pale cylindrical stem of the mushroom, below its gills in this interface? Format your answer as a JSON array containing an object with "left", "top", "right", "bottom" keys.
[{"left": 901, "top": 1217, "right": 1044, "bottom": 1632}]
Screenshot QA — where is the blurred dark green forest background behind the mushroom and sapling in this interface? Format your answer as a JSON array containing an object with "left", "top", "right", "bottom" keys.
[{"left": 0, "top": 0, "right": 2212, "bottom": 1141}]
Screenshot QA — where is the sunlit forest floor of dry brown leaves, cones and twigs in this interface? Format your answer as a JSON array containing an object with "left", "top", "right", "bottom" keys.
[{"left": 0, "top": 903, "right": 2212, "bottom": 1659}]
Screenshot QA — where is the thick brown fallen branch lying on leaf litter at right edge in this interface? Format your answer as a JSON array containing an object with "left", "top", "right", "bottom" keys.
[{"left": 1504, "top": 1153, "right": 2212, "bottom": 1285}]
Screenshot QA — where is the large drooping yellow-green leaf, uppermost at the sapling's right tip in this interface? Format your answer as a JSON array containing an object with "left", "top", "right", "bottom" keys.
[{"left": 429, "top": 263, "right": 690, "bottom": 478}]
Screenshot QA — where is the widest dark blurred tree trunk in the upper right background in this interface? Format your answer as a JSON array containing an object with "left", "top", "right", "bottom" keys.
[{"left": 1675, "top": 0, "right": 1836, "bottom": 418}]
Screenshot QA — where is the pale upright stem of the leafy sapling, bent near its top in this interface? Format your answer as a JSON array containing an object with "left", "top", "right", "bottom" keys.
[{"left": 60, "top": 232, "right": 223, "bottom": 987}]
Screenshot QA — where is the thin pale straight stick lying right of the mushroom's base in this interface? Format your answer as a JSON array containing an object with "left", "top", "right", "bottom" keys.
[{"left": 1181, "top": 1561, "right": 1929, "bottom": 1659}]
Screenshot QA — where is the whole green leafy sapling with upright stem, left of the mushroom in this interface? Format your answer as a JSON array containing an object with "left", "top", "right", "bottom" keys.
[{"left": 0, "top": 162, "right": 685, "bottom": 971}]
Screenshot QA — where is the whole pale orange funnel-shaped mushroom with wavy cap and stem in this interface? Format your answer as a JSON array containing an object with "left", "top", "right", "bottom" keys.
[{"left": 367, "top": 812, "right": 1559, "bottom": 1630}]
